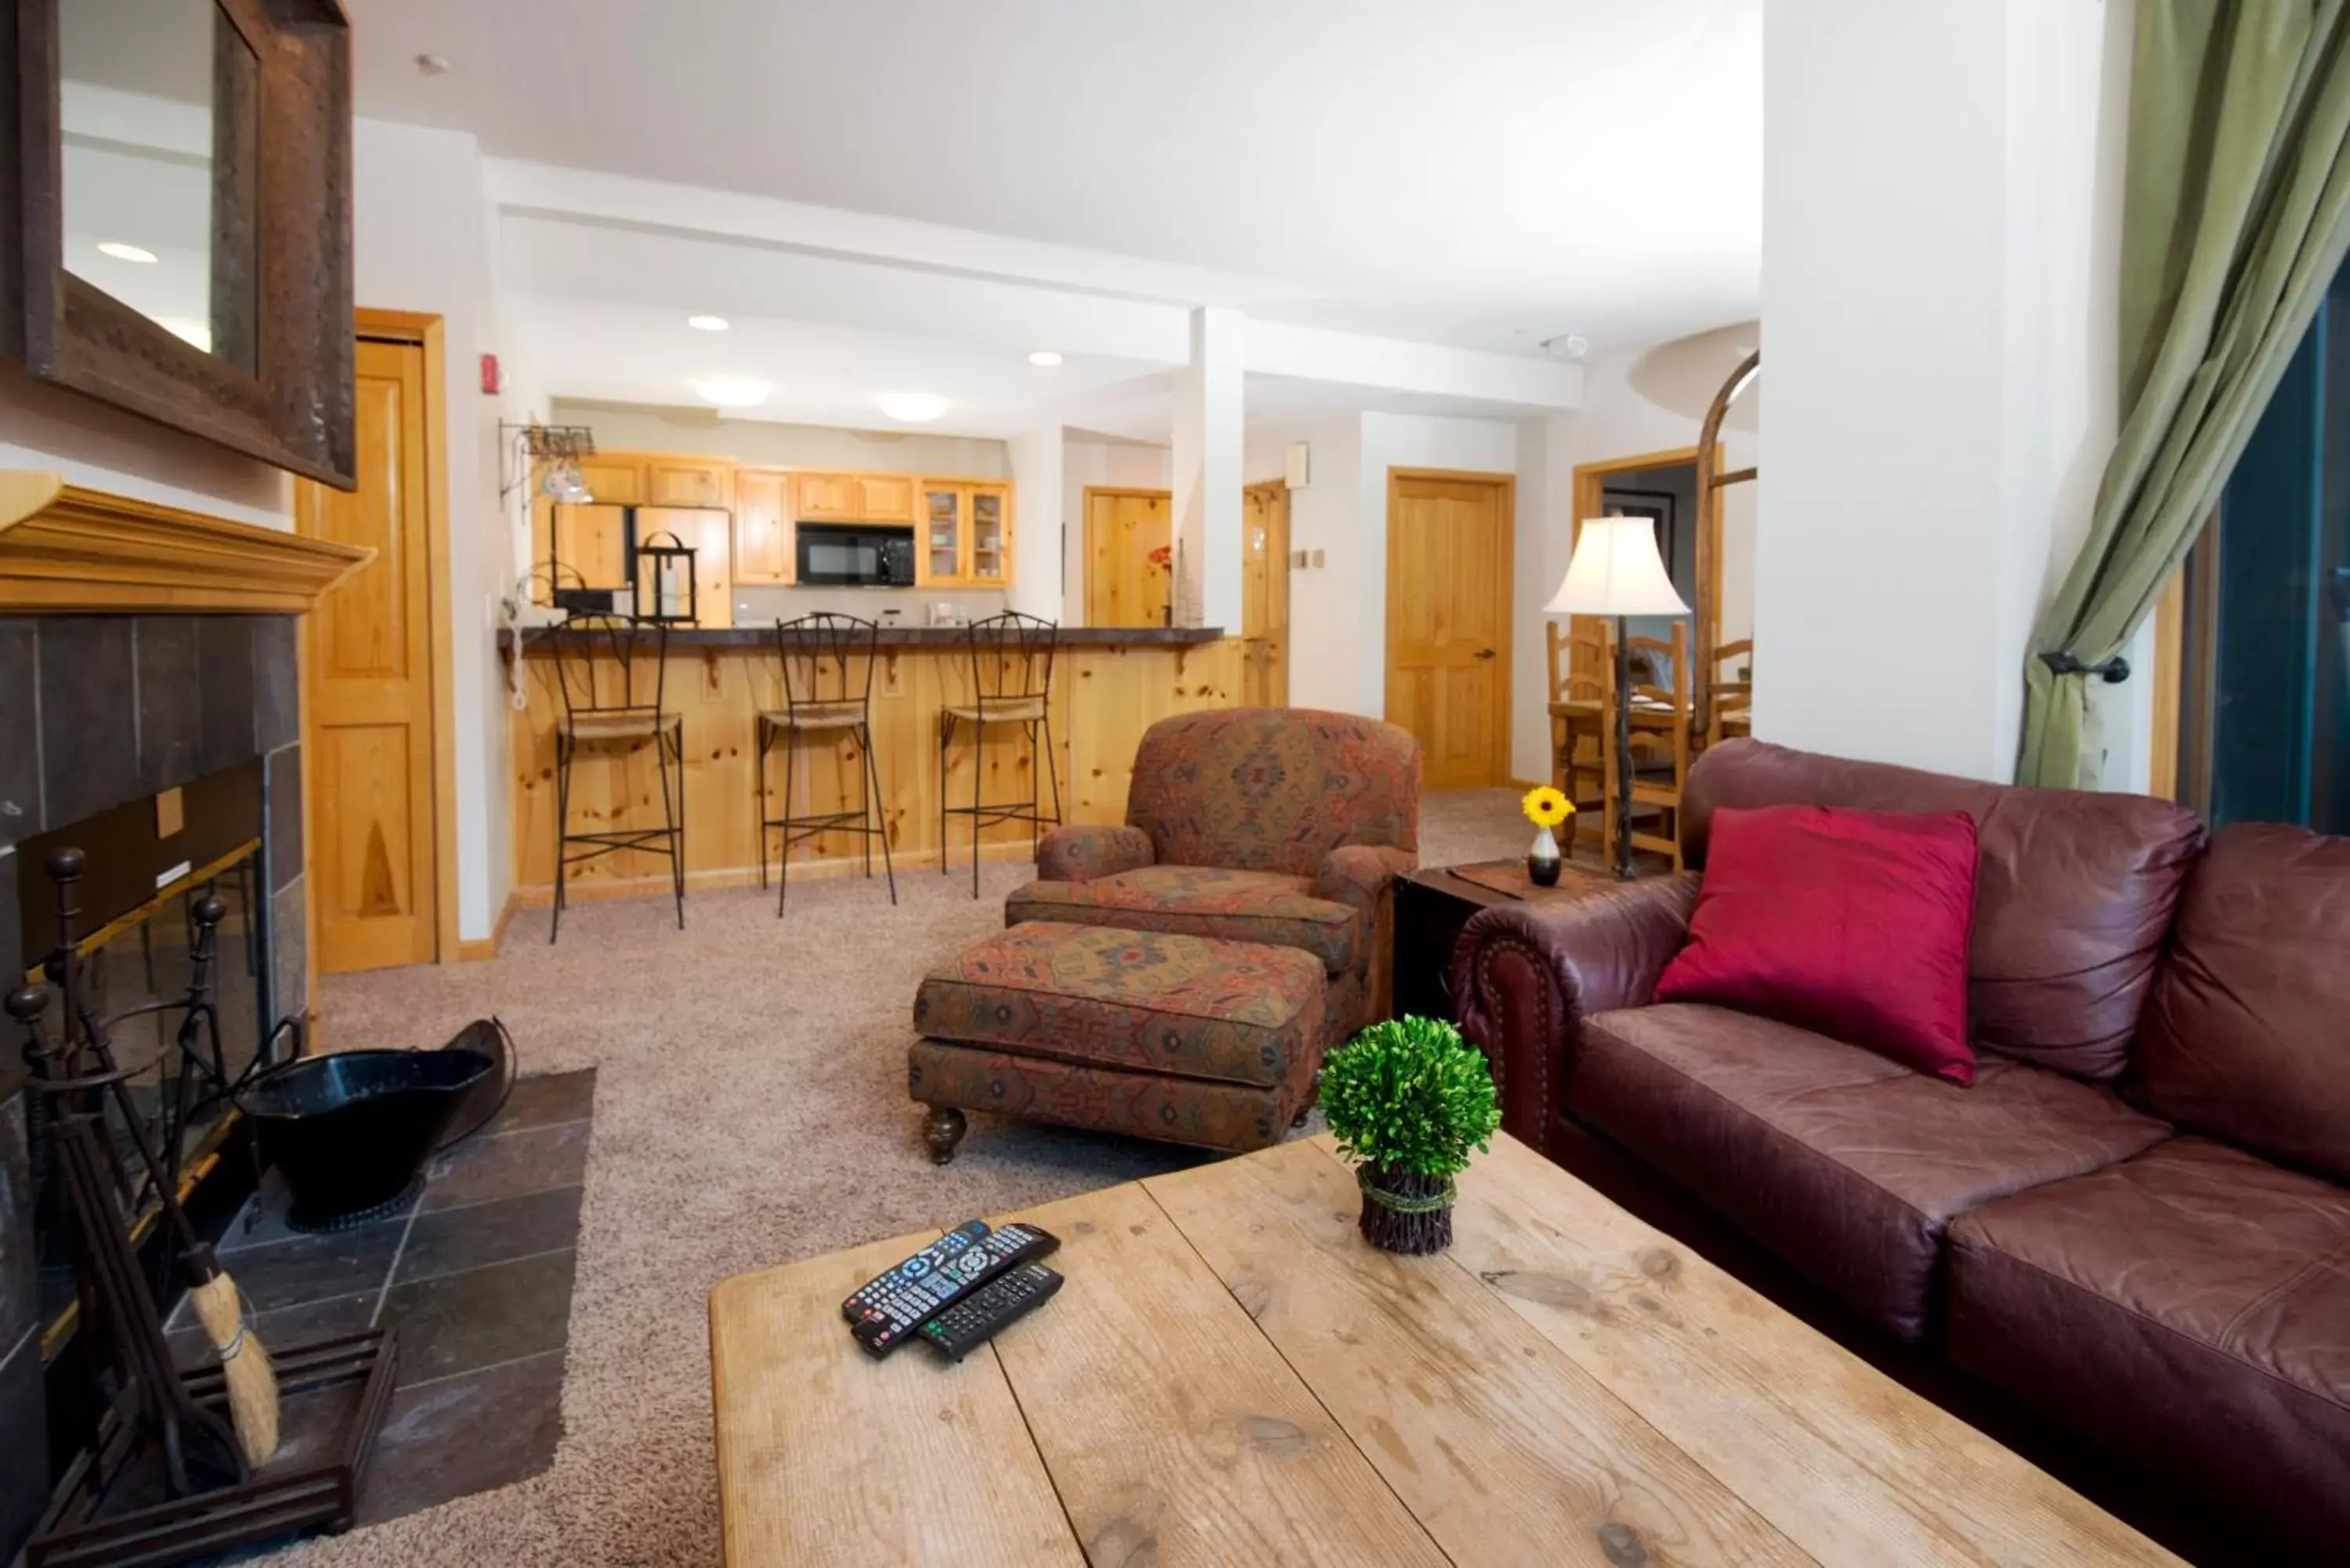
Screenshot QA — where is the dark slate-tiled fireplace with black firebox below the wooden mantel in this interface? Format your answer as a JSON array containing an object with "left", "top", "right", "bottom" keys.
[{"left": 0, "top": 616, "right": 308, "bottom": 1561}]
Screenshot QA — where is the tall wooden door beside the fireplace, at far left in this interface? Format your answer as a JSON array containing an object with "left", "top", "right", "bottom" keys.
[{"left": 294, "top": 338, "right": 439, "bottom": 974}]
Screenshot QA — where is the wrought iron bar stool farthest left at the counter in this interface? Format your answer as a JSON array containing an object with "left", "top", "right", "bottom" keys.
[{"left": 548, "top": 613, "right": 686, "bottom": 943}]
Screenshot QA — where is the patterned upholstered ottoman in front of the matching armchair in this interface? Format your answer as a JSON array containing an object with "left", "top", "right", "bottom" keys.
[{"left": 907, "top": 922, "right": 1323, "bottom": 1164}]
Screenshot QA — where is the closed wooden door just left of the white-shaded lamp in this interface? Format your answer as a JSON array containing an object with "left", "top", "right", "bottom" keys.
[{"left": 1386, "top": 468, "right": 1516, "bottom": 790}]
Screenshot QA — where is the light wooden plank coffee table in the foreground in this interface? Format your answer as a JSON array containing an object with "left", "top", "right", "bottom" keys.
[{"left": 710, "top": 1136, "right": 2176, "bottom": 1568}]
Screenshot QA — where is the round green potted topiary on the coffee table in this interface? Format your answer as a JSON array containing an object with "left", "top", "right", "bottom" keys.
[{"left": 1321, "top": 1018, "right": 1502, "bottom": 1258}]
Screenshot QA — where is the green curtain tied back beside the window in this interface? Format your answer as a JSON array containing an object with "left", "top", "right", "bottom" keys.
[{"left": 2016, "top": 0, "right": 2350, "bottom": 788}]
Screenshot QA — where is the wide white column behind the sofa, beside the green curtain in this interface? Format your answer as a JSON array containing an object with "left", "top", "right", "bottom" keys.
[{"left": 1753, "top": 0, "right": 2131, "bottom": 780}]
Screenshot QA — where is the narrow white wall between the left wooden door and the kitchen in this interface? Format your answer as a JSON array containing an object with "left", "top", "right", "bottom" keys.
[{"left": 352, "top": 120, "right": 512, "bottom": 941}]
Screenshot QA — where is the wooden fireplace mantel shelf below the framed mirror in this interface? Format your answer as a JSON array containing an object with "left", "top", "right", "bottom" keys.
[{"left": 0, "top": 468, "right": 376, "bottom": 616}]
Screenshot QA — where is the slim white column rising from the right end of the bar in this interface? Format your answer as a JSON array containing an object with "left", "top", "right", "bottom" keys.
[{"left": 1175, "top": 305, "right": 1246, "bottom": 632}]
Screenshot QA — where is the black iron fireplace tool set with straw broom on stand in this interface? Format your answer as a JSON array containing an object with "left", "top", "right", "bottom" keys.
[{"left": 5, "top": 849, "right": 395, "bottom": 1568}]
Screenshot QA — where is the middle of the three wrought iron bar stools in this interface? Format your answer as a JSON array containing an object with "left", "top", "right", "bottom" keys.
[{"left": 752, "top": 611, "right": 898, "bottom": 917}]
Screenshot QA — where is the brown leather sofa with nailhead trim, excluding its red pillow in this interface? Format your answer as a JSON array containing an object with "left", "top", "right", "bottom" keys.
[{"left": 1452, "top": 740, "right": 2350, "bottom": 1561}]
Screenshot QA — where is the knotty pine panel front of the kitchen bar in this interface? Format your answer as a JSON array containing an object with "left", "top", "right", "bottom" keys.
[{"left": 508, "top": 630, "right": 1241, "bottom": 905}]
